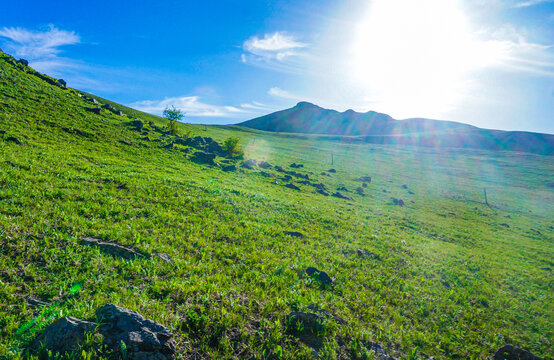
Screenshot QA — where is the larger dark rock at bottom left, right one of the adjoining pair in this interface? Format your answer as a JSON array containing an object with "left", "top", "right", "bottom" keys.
[{"left": 96, "top": 304, "right": 175, "bottom": 360}]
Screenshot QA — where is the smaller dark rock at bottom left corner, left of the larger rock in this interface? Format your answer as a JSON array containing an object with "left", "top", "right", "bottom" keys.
[{"left": 29, "top": 316, "right": 97, "bottom": 355}]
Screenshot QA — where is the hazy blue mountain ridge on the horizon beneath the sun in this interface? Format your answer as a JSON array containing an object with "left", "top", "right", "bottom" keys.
[{"left": 237, "top": 102, "right": 554, "bottom": 155}]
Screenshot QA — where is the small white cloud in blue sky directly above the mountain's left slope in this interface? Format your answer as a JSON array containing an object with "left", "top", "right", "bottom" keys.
[{"left": 241, "top": 32, "right": 308, "bottom": 72}]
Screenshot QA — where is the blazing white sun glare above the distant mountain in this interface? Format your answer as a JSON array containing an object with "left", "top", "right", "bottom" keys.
[{"left": 351, "top": 0, "right": 498, "bottom": 117}]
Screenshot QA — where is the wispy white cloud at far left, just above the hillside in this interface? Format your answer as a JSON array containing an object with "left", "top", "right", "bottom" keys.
[{"left": 0, "top": 25, "right": 80, "bottom": 60}]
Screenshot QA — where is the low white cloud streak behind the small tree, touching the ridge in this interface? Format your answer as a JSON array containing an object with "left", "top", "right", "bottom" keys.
[{"left": 129, "top": 96, "right": 263, "bottom": 121}]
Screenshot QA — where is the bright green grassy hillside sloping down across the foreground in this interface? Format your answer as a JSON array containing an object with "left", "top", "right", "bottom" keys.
[{"left": 0, "top": 54, "right": 554, "bottom": 359}]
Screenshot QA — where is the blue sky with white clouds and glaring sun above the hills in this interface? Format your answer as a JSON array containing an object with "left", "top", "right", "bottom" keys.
[{"left": 0, "top": 0, "right": 554, "bottom": 134}]
